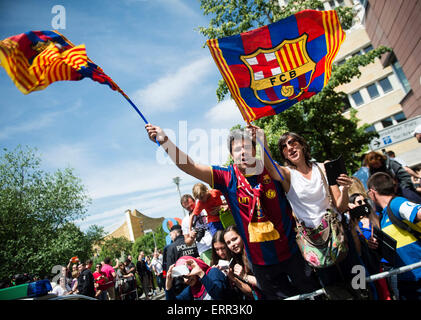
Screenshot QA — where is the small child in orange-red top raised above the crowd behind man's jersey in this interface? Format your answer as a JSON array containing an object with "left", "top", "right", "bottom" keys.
[{"left": 189, "top": 183, "right": 228, "bottom": 236}]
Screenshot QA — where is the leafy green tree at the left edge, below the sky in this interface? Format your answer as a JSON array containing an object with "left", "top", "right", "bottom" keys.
[{"left": 0, "top": 146, "right": 103, "bottom": 278}]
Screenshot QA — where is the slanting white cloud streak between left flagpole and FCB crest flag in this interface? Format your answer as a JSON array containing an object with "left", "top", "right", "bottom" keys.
[{"left": 132, "top": 57, "right": 213, "bottom": 114}]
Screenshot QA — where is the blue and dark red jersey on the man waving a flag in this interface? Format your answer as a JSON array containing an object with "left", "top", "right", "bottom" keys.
[{"left": 211, "top": 165, "right": 298, "bottom": 265}]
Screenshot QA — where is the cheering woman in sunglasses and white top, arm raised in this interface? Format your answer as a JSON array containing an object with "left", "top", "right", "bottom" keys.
[{"left": 247, "top": 125, "right": 359, "bottom": 294}]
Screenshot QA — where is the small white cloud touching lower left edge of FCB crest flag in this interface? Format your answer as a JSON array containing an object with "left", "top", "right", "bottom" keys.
[{"left": 205, "top": 99, "right": 244, "bottom": 128}]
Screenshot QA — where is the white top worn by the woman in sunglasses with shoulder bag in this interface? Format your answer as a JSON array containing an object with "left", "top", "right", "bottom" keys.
[{"left": 286, "top": 163, "right": 330, "bottom": 228}]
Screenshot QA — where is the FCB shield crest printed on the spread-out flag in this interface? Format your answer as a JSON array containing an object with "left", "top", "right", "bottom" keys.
[{"left": 240, "top": 33, "right": 316, "bottom": 104}]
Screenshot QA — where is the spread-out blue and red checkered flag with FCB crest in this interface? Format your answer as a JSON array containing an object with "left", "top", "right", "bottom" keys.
[{"left": 207, "top": 10, "right": 345, "bottom": 122}]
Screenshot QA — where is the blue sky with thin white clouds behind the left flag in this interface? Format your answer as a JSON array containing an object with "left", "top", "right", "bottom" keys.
[{"left": 0, "top": 0, "right": 243, "bottom": 232}]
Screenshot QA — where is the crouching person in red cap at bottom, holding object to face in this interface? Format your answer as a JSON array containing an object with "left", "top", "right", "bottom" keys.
[{"left": 165, "top": 256, "right": 230, "bottom": 300}]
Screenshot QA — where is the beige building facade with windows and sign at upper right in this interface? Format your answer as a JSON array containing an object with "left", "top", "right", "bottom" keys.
[{"left": 335, "top": 0, "right": 421, "bottom": 166}]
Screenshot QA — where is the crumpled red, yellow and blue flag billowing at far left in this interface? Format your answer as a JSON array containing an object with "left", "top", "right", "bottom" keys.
[{"left": 0, "top": 31, "right": 126, "bottom": 96}]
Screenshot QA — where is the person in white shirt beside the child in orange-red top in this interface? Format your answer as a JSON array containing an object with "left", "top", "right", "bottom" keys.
[{"left": 181, "top": 194, "right": 212, "bottom": 265}]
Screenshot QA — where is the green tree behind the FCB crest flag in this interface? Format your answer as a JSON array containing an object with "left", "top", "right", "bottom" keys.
[{"left": 199, "top": 0, "right": 390, "bottom": 172}]
